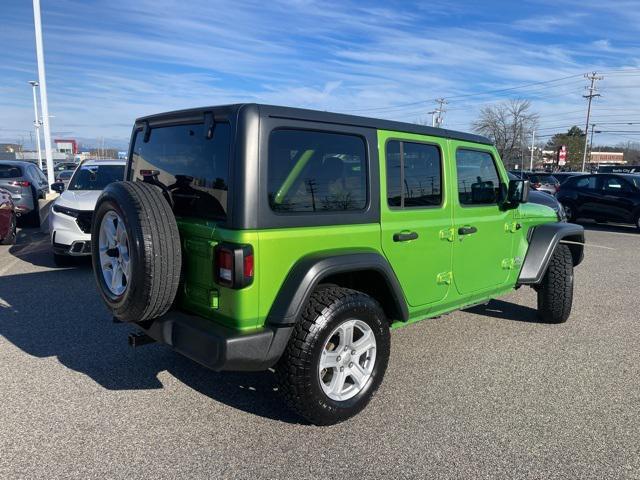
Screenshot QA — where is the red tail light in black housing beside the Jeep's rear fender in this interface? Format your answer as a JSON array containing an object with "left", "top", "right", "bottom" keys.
[{"left": 214, "top": 243, "right": 254, "bottom": 289}]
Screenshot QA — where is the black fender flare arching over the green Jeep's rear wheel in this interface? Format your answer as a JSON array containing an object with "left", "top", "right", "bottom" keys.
[{"left": 266, "top": 250, "right": 409, "bottom": 326}]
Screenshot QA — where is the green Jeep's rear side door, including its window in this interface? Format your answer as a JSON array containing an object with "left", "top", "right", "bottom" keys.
[{"left": 378, "top": 131, "right": 454, "bottom": 306}]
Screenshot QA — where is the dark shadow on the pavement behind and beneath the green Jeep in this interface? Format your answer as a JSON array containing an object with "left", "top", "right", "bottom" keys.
[{"left": 0, "top": 244, "right": 303, "bottom": 423}]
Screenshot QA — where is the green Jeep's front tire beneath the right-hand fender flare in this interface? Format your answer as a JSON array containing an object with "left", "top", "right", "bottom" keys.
[{"left": 537, "top": 244, "right": 573, "bottom": 323}]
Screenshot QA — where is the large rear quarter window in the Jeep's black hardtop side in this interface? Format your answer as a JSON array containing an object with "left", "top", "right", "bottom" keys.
[{"left": 267, "top": 130, "right": 367, "bottom": 212}]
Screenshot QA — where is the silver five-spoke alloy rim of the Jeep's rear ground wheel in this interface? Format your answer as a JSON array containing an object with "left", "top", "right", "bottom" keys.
[{"left": 318, "top": 319, "right": 376, "bottom": 401}]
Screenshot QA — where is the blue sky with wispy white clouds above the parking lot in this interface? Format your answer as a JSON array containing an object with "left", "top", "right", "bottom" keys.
[{"left": 0, "top": 0, "right": 640, "bottom": 146}]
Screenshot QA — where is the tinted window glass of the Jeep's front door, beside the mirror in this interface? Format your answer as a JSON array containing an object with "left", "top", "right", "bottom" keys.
[{"left": 456, "top": 149, "right": 500, "bottom": 205}]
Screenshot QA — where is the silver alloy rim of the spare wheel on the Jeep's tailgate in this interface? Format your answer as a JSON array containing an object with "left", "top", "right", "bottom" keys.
[{"left": 98, "top": 210, "right": 131, "bottom": 296}]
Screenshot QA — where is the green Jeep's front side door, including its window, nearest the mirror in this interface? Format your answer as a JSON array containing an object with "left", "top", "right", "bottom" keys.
[{"left": 450, "top": 141, "right": 516, "bottom": 295}]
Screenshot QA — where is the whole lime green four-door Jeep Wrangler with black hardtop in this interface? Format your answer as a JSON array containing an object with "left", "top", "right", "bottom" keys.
[{"left": 92, "top": 104, "right": 584, "bottom": 425}]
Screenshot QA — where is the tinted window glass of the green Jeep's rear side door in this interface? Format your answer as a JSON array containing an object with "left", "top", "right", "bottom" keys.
[{"left": 386, "top": 140, "right": 442, "bottom": 207}]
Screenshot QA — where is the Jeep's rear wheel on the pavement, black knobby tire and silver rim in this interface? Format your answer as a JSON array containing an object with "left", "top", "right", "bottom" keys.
[{"left": 276, "top": 286, "right": 390, "bottom": 425}]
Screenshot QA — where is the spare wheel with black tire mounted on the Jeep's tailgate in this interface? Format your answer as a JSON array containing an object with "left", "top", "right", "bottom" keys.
[{"left": 91, "top": 182, "right": 182, "bottom": 322}]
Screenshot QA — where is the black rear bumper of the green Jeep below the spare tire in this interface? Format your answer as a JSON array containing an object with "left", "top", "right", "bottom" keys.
[{"left": 143, "top": 310, "right": 293, "bottom": 371}]
